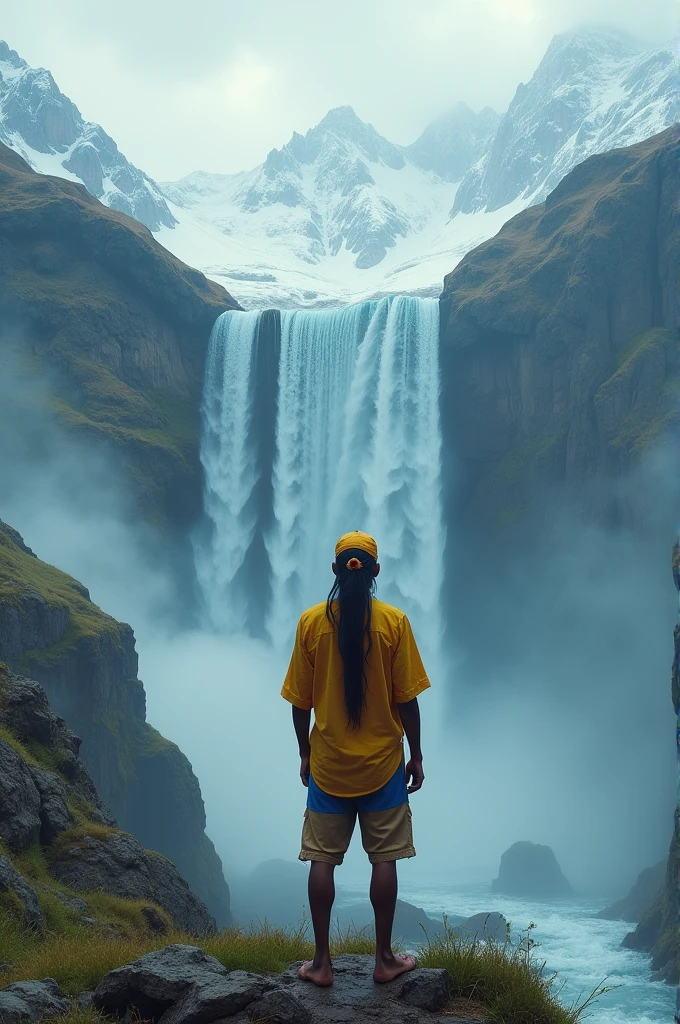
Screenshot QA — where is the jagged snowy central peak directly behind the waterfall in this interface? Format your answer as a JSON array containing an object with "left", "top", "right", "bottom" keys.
[{"left": 161, "top": 106, "right": 497, "bottom": 270}]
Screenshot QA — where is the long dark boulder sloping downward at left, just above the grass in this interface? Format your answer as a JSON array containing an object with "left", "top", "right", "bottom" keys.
[{"left": 50, "top": 831, "right": 215, "bottom": 935}]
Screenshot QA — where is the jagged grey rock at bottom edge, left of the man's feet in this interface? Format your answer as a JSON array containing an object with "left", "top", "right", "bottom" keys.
[{"left": 93, "top": 943, "right": 227, "bottom": 1019}]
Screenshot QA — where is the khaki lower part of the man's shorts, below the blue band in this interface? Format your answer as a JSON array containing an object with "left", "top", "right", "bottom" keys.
[{"left": 300, "top": 803, "right": 416, "bottom": 864}]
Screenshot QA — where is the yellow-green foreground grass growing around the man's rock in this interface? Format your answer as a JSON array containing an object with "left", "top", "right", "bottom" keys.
[{"left": 0, "top": 909, "right": 608, "bottom": 1024}]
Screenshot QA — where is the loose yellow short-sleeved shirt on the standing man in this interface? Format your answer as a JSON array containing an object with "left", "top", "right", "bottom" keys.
[{"left": 281, "top": 599, "right": 430, "bottom": 797}]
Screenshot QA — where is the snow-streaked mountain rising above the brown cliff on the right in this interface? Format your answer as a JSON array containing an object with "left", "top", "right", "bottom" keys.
[{"left": 452, "top": 31, "right": 679, "bottom": 215}]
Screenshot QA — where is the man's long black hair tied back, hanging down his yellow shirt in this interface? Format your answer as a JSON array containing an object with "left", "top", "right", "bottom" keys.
[{"left": 326, "top": 548, "right": 376, "bottom": 729}]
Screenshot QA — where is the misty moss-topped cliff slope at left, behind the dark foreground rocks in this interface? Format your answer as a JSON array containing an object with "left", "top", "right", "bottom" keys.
[{"left": 0, "top": 522, "right": 229, "bottom": 925}]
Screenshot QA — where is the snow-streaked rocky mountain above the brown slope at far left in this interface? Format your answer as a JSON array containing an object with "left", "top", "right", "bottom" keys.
[{"left": 0, "top": 40, "right": 174, "bottom": 231}]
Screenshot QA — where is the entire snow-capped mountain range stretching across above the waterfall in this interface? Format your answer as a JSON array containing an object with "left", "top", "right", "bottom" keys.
[{"left": 0, "top": 31, "right": 678, "bottom": 307}]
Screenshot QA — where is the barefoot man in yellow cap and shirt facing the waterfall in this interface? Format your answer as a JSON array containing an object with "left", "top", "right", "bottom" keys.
[{"left": 282, "top": 530, "right": 430, "bottom": 986}]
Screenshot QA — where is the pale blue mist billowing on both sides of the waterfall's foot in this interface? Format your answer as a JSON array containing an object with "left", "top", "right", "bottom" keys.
[{"left": 0, "top": 354, "right": 679, "bottom": 905}]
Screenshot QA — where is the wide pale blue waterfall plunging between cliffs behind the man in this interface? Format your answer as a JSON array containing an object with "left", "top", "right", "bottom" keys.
[{"left": 197, "top": 297, "right": 443, "bottom": 652}]
